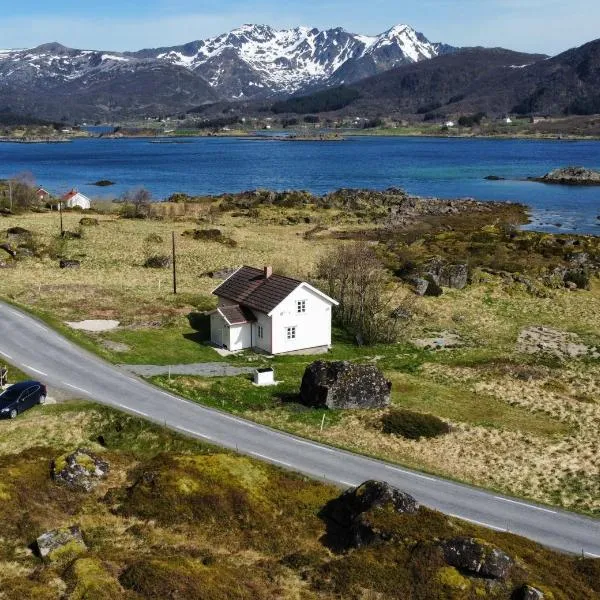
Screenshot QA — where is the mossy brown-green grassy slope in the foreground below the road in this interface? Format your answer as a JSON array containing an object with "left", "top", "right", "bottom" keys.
[{"left": 0, "top": 403, "right": 600, "bottom": 600}]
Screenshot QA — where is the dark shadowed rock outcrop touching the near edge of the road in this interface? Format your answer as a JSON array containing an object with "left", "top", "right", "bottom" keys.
[{"left": 321, "top": 481, "right": 419, "bottom": 548}]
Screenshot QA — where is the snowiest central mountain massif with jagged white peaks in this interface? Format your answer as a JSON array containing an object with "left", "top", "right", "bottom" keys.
[{"left": 133, "top": 25, "right": 450, "bottom": 99}]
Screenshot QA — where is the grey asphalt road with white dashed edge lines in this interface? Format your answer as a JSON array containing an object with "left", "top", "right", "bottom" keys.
[{"left": 0, "top": 302, "right": 600, "bottom": 558}]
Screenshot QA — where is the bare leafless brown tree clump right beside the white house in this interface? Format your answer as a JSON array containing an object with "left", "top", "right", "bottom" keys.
[{"left": 316, "top": 242, "right": 399, "bottom": 344}]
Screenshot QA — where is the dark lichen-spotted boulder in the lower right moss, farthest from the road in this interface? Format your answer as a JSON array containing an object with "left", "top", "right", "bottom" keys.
[{"left": 442, "top": 537, "right": 513, "bottom": 580}]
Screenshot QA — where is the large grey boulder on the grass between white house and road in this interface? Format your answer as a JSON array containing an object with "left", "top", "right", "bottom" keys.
[{"left": 300, "top": 360, "right": 392, "bottom": 409}]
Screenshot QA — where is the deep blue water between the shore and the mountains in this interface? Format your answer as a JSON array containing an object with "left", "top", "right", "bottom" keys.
[{"left": 0, "top": 137, "right": 600, "bottom": 234}]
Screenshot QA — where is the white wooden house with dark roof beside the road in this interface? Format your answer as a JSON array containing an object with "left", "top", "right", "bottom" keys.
[{"left": 210, "top": 267, "right": 338, "bottom": 354}]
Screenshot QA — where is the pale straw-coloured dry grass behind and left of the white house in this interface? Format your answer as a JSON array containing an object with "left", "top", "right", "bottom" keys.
[{"left": 0, "top": 211, "right": 344, "bottom": 323}]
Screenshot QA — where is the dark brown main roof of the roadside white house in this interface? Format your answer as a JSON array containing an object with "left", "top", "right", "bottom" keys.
[{"left": 214, "top": 267, "right": 302, "bottom": 314}]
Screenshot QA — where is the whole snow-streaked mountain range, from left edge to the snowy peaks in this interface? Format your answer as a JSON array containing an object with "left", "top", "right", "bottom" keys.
[{"left": 0, "top": 25, "right": 453, "bottom": 119}]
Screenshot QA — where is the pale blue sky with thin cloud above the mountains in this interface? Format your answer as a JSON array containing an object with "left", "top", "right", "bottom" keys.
[{"left": 0, "top": 0, "right": 600, "bottom": 54}]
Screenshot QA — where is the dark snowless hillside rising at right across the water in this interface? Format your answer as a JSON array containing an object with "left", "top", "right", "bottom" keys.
[{"left": 270, "top": 40, "right": 600, "bottom": 119}]
